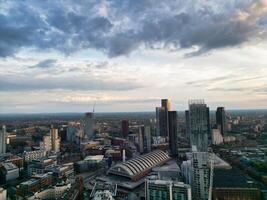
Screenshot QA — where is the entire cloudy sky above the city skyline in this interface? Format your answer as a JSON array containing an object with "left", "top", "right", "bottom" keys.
[{"left": 0, "top": 0, "right": 267, "bottom": 113}]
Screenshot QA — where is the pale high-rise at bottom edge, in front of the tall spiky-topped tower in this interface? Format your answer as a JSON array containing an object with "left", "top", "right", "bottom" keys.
[{"left": 192, "top": 151, "right": 213, "bottom": 200}]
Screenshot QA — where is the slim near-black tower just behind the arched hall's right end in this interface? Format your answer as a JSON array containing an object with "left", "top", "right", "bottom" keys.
[{"left": 168, "top": 111, "right": 178, "bottom": 157}]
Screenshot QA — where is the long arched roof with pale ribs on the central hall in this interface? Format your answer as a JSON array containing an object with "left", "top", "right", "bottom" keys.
[{"left": 109, "top": 150, "right": 170, "bottom": 178}]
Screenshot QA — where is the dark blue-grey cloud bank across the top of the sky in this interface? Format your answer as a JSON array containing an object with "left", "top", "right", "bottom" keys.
[{"left": 0, "top": 0, "right": 266, "bottom": 57}]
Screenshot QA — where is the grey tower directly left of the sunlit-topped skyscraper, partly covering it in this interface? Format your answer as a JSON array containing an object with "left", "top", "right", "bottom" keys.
[{"left": 156, "top": 107, "right": 167, "bottom": 137}]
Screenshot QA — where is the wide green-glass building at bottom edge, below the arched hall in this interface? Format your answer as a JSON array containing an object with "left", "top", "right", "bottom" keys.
[{"left": 145, "top": 180, "right": 192, "bottom": 200}]
